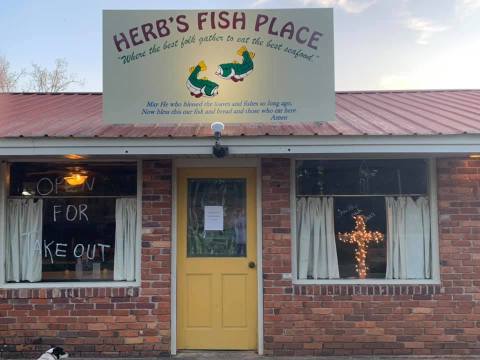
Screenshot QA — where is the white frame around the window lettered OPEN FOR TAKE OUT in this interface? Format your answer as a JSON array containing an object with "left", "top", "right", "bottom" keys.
[{"left": 0, "top": 158, "right": 143, "bottom": 289}]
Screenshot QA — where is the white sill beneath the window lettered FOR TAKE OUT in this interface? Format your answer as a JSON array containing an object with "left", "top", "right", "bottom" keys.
[{"left": 0, "top": 281, "right": 140, "bottom": 290}]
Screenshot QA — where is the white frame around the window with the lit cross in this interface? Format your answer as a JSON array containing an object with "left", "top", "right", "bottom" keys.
[{"left": 290, "top": 156, "right": 440, "bottom": 285}]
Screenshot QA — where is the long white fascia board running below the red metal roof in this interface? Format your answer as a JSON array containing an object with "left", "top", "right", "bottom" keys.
[{"left": 0, "top": 134, "right": 480, "bottom": 156}]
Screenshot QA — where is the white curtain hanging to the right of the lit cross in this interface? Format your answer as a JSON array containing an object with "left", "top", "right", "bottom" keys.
[{"left": 386, "top": 197, "right": 432, "bottom": 279}]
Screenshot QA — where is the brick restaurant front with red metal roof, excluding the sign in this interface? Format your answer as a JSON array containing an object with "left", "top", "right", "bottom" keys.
[{"left": 0, "top": 90, "right": 480, "bottom": 358}]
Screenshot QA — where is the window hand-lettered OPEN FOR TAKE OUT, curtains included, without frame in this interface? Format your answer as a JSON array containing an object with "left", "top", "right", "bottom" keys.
[{"left": 5, "top": 163, "right": 137, "bottom": 283}]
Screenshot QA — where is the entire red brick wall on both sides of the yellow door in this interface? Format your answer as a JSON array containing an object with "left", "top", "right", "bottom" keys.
[{"left": 0, "top": 159, "right": 480, "bottom": 357}]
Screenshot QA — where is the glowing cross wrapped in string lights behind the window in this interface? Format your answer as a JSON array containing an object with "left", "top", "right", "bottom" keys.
[{"left": 338, "top": 215, "right": 384, "bottom": 279}]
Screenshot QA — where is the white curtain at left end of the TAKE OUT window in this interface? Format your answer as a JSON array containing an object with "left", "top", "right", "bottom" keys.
[{"left": 5, "top": 199, "right": 43, "bottom": 282}]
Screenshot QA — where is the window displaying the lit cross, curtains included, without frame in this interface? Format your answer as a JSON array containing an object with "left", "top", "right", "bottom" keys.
[{"left": 296, "top": 159, "right": 433, "bottom": 281}]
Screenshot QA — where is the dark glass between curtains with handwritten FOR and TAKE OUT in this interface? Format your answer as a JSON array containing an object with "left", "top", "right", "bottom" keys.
[{"left": 42, "top": 198, "right": 115, "bottom": 281}]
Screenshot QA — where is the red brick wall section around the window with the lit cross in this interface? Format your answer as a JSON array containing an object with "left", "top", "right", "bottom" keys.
[{"left": 262, "top": 159, "right": 480, "bottom": 355}]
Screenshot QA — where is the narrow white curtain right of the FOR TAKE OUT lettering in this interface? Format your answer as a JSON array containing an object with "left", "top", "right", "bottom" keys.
[{"left": 113, "top": 198, "right": 137, "bottom": 281}]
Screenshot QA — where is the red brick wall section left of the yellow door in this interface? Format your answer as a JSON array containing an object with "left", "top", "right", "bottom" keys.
[{"left": 0, "top": 160, "right": 172, "bottom": 358}]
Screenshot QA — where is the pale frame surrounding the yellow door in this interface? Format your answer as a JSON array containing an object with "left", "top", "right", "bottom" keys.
[{"left": 170, "top": 157, "right": 264, "bottom": 355}]
